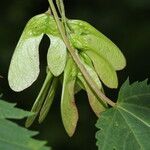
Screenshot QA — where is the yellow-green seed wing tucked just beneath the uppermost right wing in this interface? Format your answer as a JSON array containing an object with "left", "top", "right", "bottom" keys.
[{"left": 86, "top": 51, "right": 118, "bottom": 88}]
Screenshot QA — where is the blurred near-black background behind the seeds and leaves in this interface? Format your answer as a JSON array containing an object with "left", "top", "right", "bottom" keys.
[{"left": 0, "top": 0, "right": 150, "bottom": 150}]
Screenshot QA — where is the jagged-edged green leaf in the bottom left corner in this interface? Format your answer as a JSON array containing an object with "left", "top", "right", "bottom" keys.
[{"left": 0, "top": 100, "right": 50, "bottom": 150}]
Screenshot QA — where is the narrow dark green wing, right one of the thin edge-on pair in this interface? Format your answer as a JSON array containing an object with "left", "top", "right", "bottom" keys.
[{"left": 39, "top": 78, "right": 58, "bottom": 123}]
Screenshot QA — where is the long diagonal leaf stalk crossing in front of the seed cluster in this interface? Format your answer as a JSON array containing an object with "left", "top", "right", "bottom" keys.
[{"left": 48, "top": 0, "right": 116, "bottom": 107}]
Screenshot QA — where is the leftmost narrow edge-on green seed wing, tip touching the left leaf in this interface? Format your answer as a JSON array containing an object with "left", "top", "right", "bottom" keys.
[{"left": 25, "top": 71, "right": 53, "bottom": 127}]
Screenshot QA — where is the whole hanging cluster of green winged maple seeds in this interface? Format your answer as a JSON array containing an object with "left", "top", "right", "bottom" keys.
[{"left": 8, "top": 13, "right": 126, "bottom": 136}]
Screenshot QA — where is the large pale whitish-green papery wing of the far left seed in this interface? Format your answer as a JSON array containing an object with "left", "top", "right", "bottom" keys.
[{"left": 8, "top": 35, "right": 43, "bottom": 92}]
